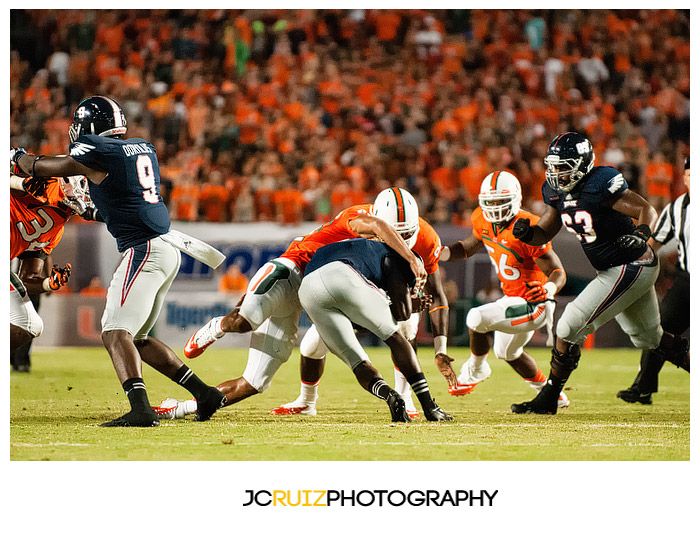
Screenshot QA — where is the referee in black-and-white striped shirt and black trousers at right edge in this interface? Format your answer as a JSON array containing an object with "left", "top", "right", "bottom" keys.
[{"left": 617, "top": 157, "right": 690, "bottom": 404}]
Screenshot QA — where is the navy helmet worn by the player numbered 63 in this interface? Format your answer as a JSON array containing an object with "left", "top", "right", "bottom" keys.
[{"left": 544, "top": 132, "right": 595, "bottom": 192}]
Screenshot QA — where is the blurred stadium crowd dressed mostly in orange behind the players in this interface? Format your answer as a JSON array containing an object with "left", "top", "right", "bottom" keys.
[{"left": 10, "top": 9, "right": 690, "bottom": 225}]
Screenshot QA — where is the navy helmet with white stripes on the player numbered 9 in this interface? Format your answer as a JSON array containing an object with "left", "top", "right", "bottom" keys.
[{"left": 68, "top": 95, "right": 126, "bottom": 143}]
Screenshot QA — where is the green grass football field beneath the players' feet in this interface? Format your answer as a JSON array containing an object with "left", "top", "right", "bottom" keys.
[{"left": 10, "top": 347, "right": 690, "bottom": 461}]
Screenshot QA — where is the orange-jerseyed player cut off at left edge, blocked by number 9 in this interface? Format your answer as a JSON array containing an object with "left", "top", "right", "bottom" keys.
[{"left": 10, "top": 174, "right": 94, "bottom": 352}]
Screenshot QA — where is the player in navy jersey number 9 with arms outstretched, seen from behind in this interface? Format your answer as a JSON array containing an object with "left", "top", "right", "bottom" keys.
[{"left": 10, "top": 96, "right": 226, "bottom": 427}]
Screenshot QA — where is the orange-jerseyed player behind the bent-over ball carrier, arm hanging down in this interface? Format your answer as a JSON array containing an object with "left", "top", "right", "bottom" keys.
[{"left": 271, "top": 188, "right": 457, "bottom": 419}]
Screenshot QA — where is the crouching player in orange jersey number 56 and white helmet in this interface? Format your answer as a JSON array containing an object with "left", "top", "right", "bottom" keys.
[{"left": 440, "top": 171, "right": 569, "bottom": 407}]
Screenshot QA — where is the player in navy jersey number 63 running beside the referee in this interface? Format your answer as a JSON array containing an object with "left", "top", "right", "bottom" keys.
[{"left": 511, "top": 132, "right": 689, "bottom": 414}]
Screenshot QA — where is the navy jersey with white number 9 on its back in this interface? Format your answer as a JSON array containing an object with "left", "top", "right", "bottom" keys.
[{"left": 70, "top": 134, "right": 170, "bottom": 251}]
